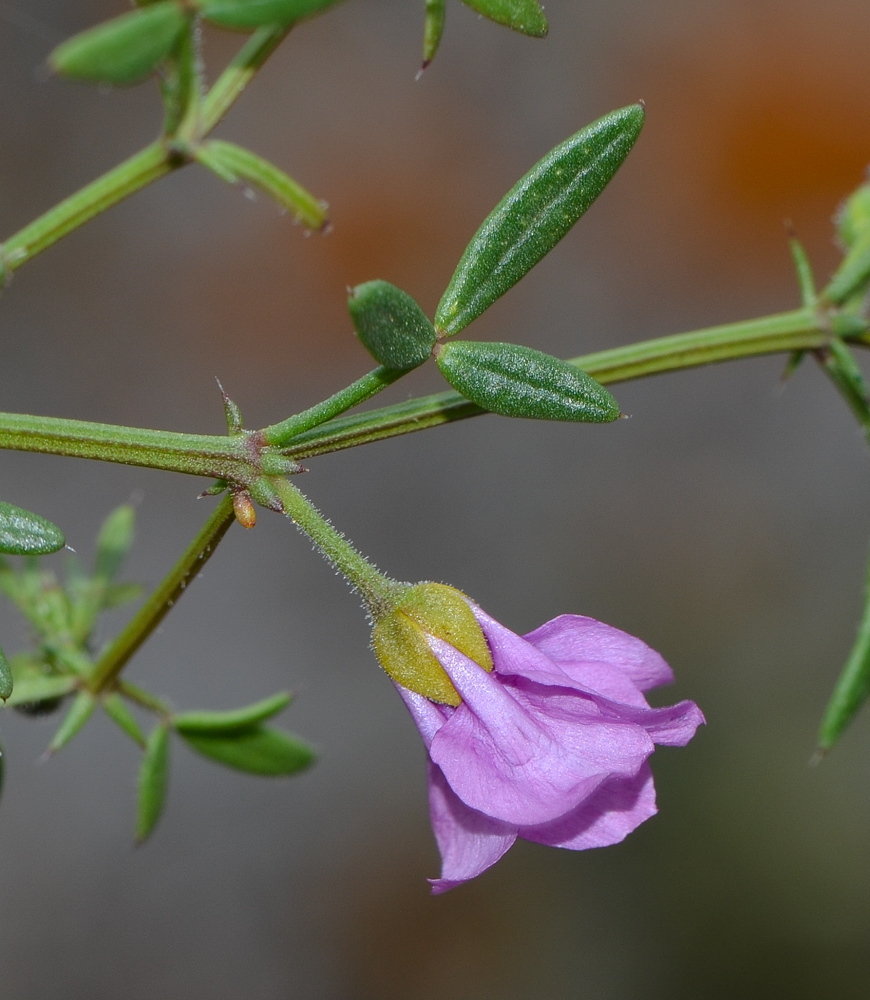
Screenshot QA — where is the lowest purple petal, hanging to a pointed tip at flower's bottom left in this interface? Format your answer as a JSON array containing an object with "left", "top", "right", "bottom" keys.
[{"left": 428, "top": 761, "right": 517, "bottom": 895}]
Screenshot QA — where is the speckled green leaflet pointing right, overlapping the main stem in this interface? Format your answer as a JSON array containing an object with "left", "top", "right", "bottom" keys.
[{"left": 438, "top": 340, "right": 619, "bottom": 423}]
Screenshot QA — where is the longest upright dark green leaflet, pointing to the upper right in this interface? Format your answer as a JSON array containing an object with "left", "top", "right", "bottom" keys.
[{"left": 435, "top": 104, "right": 644, "bottom": 334}]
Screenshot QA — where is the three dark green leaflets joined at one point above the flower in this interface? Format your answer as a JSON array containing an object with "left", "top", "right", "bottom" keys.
[{"left": 348, "top": 105, "right": 644, "bottom": 422}]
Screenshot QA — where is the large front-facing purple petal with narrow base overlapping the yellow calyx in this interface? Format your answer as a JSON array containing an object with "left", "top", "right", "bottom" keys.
[{"left": 429, "top": 639, "right": 653, "bottom": 826}]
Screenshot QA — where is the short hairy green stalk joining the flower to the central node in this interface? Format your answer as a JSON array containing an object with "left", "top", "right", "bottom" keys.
[{"left": 271, "top": 477, "right": 406, "bottom": 617}]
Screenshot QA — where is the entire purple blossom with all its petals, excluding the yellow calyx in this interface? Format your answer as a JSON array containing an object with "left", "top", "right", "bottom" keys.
[{"left": 396, "top": 602, "right": 704, "bottom": 893}]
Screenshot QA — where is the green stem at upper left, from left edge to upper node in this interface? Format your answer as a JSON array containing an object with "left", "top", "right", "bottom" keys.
[{"left": 0, "top": 140, "right": 175, "bottom": 275}]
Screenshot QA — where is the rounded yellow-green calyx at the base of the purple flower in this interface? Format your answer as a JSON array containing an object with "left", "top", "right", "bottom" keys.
[{"left": 372, "top": 583, "right": 493, "bottom": 705}]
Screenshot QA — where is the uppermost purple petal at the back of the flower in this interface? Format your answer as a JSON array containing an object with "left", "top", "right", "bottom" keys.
[{"left": 523, "top": 615, "right": 674, "bottom": 700}]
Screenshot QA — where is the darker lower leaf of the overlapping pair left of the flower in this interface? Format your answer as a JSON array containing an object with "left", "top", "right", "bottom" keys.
[{"left": 180, "top": 726, "right": 314, "bottom": 778}]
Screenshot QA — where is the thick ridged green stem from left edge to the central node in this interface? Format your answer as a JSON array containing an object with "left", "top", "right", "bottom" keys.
[{"left": 0, "top": 413, "right": 256, "bottom": 482}]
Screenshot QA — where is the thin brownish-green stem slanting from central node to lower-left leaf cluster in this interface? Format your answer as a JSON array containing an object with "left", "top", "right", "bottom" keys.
[{"left": 88, "top": 497, "right": 235, "bottom": 694}]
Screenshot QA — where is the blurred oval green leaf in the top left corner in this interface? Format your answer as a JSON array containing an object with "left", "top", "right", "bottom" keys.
[{"left": 48, "top": 0, "right": 187, "bottom": 85}]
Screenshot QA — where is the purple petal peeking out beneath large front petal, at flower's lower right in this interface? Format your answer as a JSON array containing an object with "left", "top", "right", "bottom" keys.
[{"left": 520, "top": 764, "right": 657, "bottom": 851}]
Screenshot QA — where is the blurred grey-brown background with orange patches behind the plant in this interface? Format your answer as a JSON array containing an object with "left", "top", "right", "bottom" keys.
[{"left": 0, "top": 0, "right": 870, "bottom": 1000}]
